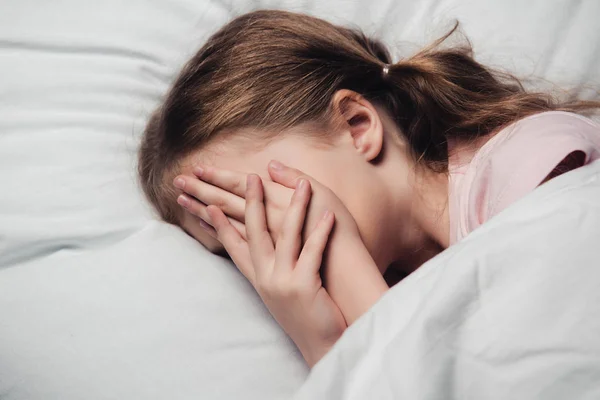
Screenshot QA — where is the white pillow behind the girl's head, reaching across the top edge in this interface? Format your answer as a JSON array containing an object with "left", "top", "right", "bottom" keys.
[{"left": 0, "top": 0, "right": 600, "bottom": 267}]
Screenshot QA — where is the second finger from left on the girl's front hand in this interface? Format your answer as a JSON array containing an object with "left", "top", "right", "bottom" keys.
[{"left": 246, "top": 174, "right": 275, "bottom": 275}]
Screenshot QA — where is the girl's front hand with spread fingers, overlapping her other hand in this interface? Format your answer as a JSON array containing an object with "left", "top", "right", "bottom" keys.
[{"left": 206, "top": 175, "right": 346, "bottom": 366}]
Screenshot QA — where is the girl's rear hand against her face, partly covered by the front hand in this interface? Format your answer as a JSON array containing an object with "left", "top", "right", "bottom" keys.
[{"left": 174, "top": 161, "right": 388, "bottom": 324}]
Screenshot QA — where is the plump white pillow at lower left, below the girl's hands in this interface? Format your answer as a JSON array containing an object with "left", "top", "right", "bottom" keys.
[{"left": 0, "top": 222, "right": 307, "bottom": 400}]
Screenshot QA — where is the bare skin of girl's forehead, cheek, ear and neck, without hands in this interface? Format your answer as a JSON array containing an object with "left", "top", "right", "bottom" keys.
[{"left": 176, "top": 91, "right": 449, "bottom": 273}]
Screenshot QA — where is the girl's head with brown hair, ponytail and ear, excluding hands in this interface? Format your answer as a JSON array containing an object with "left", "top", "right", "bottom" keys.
[{"left": 139, "top": 11, "right": 600, "bottom": 266}]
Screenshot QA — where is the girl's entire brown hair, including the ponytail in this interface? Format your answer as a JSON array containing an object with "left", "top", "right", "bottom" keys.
[{"left": 139, "top": 11, "right": 600, "bottom": 224}]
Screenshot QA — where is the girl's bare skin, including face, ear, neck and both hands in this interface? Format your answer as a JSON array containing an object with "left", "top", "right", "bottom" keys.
[{"left": 169, "top": 91, "right": 448, "bottom": 365}]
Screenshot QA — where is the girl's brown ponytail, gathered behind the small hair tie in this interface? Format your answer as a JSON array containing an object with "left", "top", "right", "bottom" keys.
[{"left": 372, "top": 23, "right": 600, "bottom": 171}]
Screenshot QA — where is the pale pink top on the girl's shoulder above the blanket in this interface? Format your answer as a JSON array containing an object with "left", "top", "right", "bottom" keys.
[{"left": 448, "top": 111, "right": 600, "bottom": 245}]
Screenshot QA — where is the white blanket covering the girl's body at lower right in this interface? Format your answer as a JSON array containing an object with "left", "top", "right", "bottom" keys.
[{"left": 297, "top": 163, "right": 600, "bottom": 400}]
